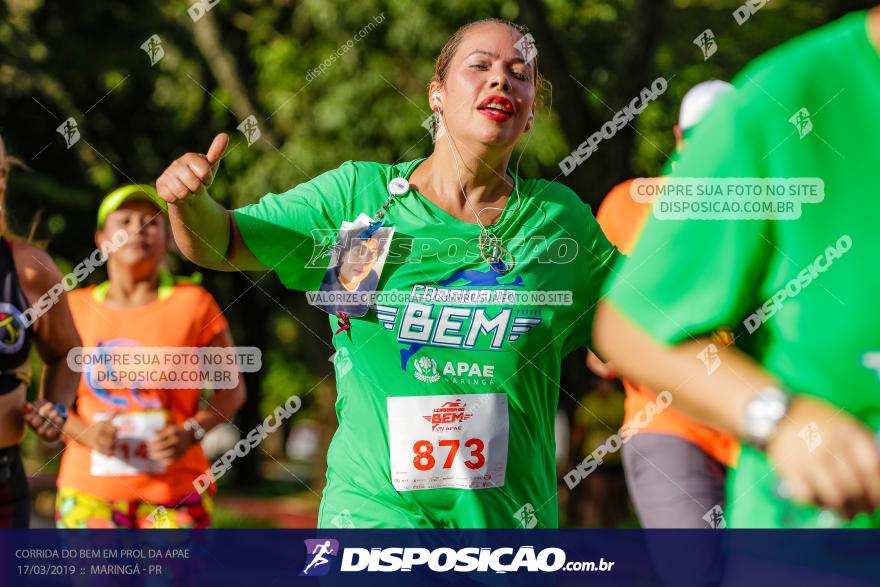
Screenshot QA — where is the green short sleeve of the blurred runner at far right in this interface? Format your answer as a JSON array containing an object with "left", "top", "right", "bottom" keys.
[{"left": 606, "top": 90, "right": 773, "bottom": 344}]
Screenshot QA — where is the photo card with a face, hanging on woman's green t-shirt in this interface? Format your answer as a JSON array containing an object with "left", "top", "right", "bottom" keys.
[{"left": 309, "top": 214, "right": 394, "bottom": 317}]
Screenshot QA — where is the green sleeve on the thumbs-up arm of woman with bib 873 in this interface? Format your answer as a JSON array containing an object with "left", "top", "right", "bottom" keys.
[{"left": 234, "top": 161, "right": 355, "bottom": 290}]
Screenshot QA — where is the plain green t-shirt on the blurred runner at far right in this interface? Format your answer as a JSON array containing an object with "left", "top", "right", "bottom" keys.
[{"left": 607, "top": 12, "right": 880, "bottom": 527}]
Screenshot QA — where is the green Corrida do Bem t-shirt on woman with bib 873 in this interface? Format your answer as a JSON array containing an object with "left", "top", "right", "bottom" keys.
[{"left": 235, "top": 160, "right": 616, "bottom": 527}]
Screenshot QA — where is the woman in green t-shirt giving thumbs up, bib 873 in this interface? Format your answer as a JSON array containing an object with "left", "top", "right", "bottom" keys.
[{"left": 156, "top": 20, "right": 615, "bottom": 528}]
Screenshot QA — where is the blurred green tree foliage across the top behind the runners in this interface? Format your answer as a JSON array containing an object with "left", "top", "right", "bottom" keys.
[{"left": 0, "top": 0, "right": 852, "bottom": 239}]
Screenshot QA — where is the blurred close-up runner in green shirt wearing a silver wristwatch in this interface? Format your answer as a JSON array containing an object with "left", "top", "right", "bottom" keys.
[{"left": 595, "top": 8, "right": 880, "bottom": 528}]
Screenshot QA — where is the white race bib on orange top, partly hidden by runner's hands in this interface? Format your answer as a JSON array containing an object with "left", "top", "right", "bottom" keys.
[{"left": 90, "top": 410, "right": 166, "bottom": 477}]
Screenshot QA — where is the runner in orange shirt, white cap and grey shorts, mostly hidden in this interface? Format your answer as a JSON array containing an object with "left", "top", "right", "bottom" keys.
[{"left": 587, "top": 80, "right": 739, "bottom": 528}]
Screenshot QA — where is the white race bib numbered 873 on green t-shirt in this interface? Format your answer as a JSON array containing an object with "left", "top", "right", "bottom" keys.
[{"left": 388, "top": 393, "right": 509, "bottom": 491}]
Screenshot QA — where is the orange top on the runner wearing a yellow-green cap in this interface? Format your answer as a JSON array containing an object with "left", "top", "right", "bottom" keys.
[{"left": 57, "top": 285, "right": 227, "bottom": 504}]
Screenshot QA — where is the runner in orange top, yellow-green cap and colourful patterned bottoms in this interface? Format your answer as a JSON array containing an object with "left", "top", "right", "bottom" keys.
[{"left": 55, "top": 185, "right": 245, "bottom": 528}]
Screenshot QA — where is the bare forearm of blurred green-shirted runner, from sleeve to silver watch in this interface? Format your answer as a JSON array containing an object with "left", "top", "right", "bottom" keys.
[{"left": 593, "top": 302, "right": 774, "bottom": 434}]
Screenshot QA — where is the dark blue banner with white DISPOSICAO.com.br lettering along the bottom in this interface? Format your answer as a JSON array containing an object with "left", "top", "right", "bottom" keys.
[{"left": 0, "top": 530, "right": 880, "bottom": 587}]
